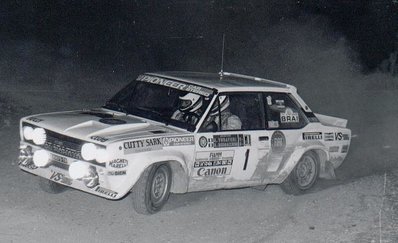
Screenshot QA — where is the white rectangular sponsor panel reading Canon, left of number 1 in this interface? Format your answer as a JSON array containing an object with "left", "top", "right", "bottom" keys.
[{"left": 193, "top": 150, "right": 234, "bottom": 177}]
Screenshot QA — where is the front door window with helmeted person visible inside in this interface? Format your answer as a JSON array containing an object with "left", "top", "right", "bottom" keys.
[{"left": 200, "top": 92, "right": 265, "bottom": 131}]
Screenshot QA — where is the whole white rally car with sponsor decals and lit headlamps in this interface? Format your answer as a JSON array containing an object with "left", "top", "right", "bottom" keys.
[{"left": 19, "top": 72, "right": 351, "bottom": 214}]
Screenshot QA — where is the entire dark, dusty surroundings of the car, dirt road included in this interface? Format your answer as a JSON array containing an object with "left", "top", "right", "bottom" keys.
[{"left": 0, "top": 3, "right": 398, "bottom": 242}]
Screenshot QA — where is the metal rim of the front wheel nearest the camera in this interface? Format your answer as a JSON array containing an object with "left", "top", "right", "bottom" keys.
[{"left": 151, "top": 166, "right": 169, "bottom": 206}]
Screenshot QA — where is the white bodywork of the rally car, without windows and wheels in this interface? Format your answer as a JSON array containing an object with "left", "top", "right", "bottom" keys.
[{"left": 20, "top": 72, "right": 351, "bottom": 213}]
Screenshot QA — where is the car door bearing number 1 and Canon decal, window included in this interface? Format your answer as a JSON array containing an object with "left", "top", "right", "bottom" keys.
[{"left": 190, "top": 92, "right": 270, "bottom": 190}]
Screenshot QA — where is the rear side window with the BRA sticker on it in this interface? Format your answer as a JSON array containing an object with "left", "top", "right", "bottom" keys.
[{"left": 264, "top": 93, "right": 308, "bottom": 129}]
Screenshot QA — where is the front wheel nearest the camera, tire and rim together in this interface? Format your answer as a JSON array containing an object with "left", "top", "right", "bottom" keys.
[{"left": 131, "top": 164, "right": 172, "bottom": 214}]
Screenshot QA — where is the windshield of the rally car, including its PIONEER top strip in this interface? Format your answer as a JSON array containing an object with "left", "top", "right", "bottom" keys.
[{"left": 103, "top": 75, "right": 213, "bottom": 130}]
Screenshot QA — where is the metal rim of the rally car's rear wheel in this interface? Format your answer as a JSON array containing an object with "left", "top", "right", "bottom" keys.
[{"left": 296, "top": 155, "right": 316, "bottom": 189}]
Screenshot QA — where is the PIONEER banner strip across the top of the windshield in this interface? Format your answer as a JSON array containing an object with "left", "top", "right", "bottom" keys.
[{"left": 137, "top": 75, "right": 213, "bottom": 97}]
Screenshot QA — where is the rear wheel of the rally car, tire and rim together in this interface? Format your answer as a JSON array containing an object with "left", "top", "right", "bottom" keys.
[{"left": 280, "top": 151, "right": 319, "bottom": 195}]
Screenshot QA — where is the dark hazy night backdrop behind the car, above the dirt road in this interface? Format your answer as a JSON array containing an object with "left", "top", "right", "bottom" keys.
[{"left": 0, "top": 0, "right": 398, "bottom": 180}]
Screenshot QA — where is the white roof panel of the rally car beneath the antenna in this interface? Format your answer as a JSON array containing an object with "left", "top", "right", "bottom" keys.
[{"left": 146, "top": 71, "right": 294, "bottom": 91}]
